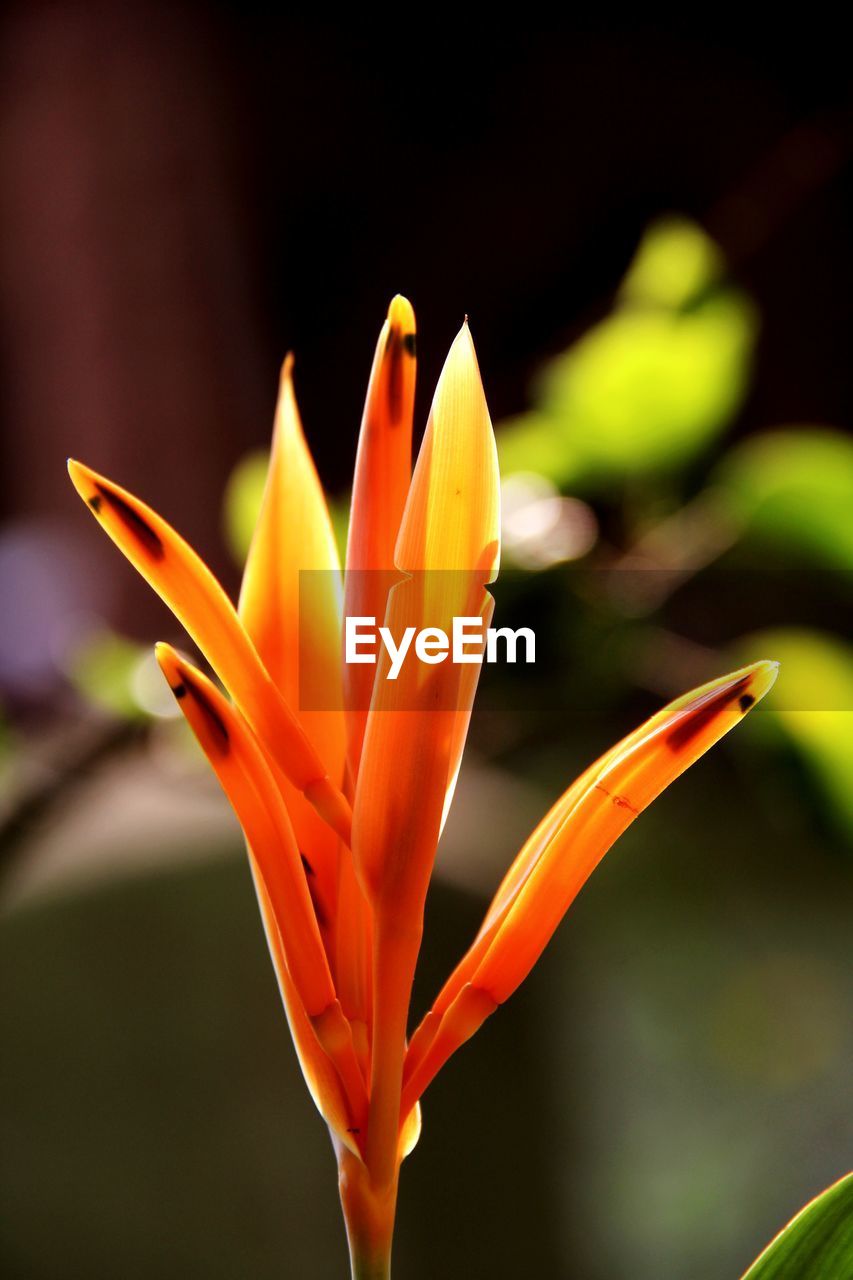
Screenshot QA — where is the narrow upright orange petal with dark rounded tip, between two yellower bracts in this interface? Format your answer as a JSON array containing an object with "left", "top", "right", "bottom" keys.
[{"left": 343, "top": 294, "right": 416, "bottom": 777}]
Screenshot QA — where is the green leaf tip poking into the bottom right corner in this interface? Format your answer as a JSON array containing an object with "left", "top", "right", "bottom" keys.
[{"left": 743, "top": 1174, "right": 853, "bottom": 1280}]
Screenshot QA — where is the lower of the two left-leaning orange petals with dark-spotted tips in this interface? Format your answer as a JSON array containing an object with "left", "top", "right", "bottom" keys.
[{"left": 156, "top": 644, "right": 366, "bottom": 1114}]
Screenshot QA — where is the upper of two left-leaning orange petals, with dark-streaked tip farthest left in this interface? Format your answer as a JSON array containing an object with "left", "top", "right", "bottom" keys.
[{"left": 68, "top": 460, "right": 350, "bottom": 840}]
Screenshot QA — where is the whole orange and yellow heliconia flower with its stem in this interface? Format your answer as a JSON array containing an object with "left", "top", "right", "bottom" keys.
[{"left": 69, "top": 297, "right": 776, "bottom": 1280}]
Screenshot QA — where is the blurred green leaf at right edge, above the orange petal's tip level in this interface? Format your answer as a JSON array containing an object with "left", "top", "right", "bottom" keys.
[{"left": 713, "top": 428, "right": 853, "bottom": 568}]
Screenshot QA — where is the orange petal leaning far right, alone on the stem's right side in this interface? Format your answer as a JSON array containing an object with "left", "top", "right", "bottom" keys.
[{"left": 403, "top": 662, "right": 777, "bottom": 1114}]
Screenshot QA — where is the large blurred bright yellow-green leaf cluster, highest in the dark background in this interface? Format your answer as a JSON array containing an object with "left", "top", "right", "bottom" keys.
[{"left": 498, "top": 219, "right": 757, "bottom": 490}]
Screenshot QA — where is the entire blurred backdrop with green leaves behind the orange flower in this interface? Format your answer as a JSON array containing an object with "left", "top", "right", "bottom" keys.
[{"left": 0, "top": 10, "right": 853, "bottom": 1280}]
